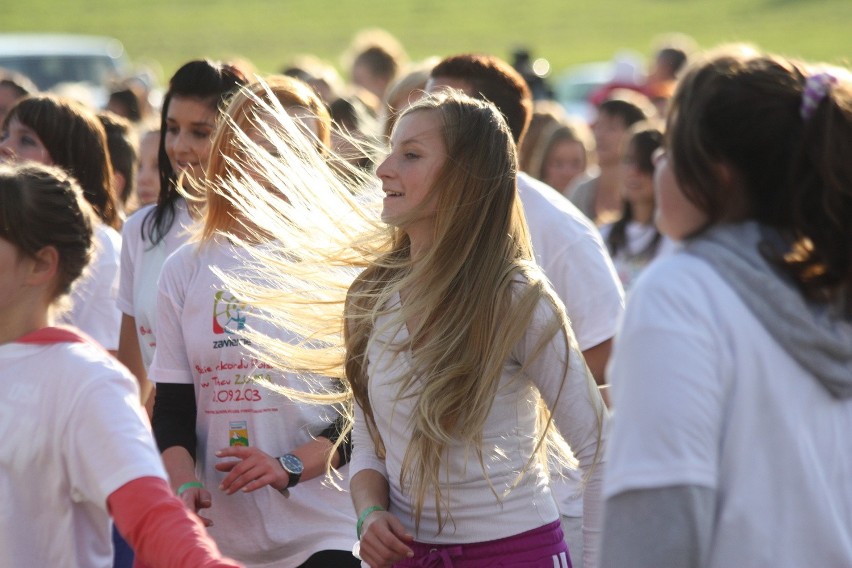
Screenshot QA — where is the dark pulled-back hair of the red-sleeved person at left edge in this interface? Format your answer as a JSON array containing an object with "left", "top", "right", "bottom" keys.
[{"left": 0, "top": 162, "right": 96, "bottom": 300}]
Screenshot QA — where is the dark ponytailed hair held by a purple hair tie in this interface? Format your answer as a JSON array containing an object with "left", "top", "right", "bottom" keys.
[{"left": 666, "top": 45, "right": 852, "bottom": 313}]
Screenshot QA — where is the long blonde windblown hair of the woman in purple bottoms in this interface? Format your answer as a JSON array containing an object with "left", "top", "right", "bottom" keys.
[{"left": 211, "top": 92, "right": 602, "bottom": 527}]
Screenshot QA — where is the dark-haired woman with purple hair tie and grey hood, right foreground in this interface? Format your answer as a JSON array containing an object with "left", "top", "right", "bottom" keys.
[{"left": 601, "top": 46, "right": 852, "bottom": 568}]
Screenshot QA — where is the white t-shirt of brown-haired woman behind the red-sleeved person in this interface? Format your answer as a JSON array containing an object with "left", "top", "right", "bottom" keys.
[{"left": 58, "top": 223, "right": 121, "bottom": 351}]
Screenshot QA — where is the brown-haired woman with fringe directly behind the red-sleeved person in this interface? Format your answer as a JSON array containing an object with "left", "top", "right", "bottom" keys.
[{"left": 0, "top": 95, "right": 121, "bottom": 352}]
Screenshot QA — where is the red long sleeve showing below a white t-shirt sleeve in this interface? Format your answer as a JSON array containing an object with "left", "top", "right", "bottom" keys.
[{"left": 107, "top": 477, "right": 240, "bottom": 568}]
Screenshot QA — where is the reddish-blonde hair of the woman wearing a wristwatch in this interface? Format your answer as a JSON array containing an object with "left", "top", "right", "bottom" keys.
[{"left": 201, "top": 75, "right": 331, "bottom": 240}]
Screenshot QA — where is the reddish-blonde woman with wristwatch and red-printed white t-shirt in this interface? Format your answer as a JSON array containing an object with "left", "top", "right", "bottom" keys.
[{"left": 150, "top": 77, "right": 359, "bottom": 568}]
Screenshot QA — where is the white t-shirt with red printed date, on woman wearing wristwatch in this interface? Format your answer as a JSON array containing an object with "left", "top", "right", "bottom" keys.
[{"left": 150, "top": 240, "right": 356, "bottom": 566}]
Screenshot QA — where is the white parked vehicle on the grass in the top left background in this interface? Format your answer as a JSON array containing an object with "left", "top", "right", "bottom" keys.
[{"left": 0, "top": 33, "right": 130, "bottom": 104}]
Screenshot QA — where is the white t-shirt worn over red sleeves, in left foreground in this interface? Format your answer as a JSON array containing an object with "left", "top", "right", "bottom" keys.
[{"left": 0, "top": 336, "right": 166, "bottom": 568}]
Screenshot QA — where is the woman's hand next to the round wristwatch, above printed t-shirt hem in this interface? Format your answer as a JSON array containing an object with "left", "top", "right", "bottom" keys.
[{"left": 216, "top": 446, "right": 290, "bottom": 495}]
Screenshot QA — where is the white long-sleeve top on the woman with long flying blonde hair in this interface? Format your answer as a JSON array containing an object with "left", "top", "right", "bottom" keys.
[{"left": 350, "top": 290, "right": 607, "bottom": 566}]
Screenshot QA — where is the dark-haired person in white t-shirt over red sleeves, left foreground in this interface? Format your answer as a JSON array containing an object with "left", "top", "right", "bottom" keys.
[{"left": 0, "top": 163, "right": 238, "bottom": 568}]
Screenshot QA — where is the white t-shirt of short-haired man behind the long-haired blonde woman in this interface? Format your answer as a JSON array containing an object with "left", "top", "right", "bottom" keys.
[{"left": 518, "top": 172, "right": 624, "bottom": 517}]
